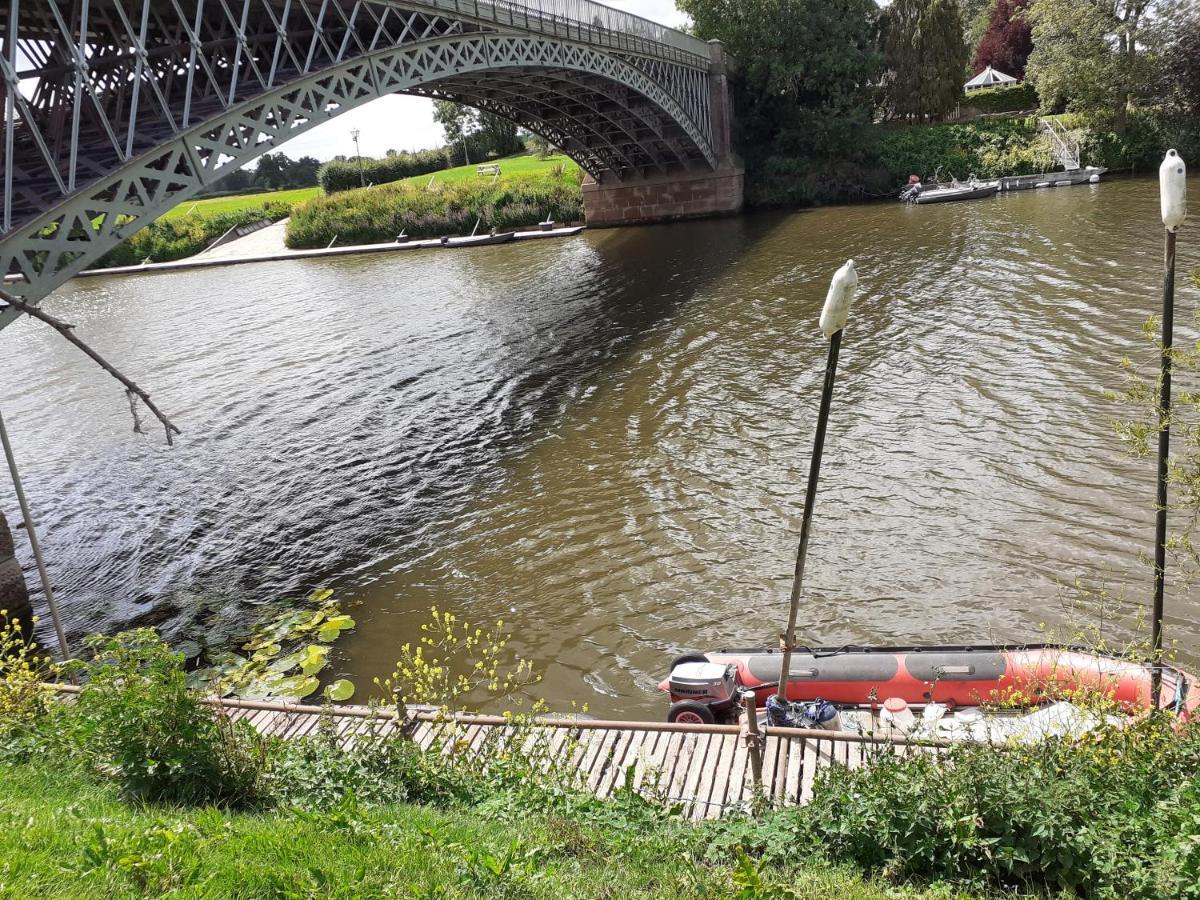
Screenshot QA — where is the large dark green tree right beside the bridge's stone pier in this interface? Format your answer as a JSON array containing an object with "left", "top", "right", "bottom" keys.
[{"left": 677, "top": 0, "right": 881, "bottom": 204}]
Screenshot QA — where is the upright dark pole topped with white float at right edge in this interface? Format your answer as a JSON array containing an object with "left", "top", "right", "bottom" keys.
[{"left": 1150, "top": 150, "right": 1188, "bottom": 709}]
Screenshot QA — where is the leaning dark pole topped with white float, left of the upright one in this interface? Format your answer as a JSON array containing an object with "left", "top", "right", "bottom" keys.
[{"left": 778, "top": 259, "right": 858, "bottom": 701}]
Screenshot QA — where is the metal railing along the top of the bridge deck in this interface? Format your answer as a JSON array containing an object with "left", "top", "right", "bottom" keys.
[{"left": 412, "top": 0, "right": 709, "bottom": 66}]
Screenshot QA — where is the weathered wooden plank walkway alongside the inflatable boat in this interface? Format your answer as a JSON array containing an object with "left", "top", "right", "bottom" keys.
[{"left": 210, "top": 700, "right": 946, "bottom": 820}]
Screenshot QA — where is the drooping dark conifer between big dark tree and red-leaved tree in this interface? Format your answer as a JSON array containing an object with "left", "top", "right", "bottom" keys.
[{"left": 883, "top": 0, "right": 967, "bottom": 119}]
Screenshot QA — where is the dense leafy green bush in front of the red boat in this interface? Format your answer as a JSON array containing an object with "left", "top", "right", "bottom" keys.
[{"left": 734, "top": 716, "right": 1200, "bottom": 898}]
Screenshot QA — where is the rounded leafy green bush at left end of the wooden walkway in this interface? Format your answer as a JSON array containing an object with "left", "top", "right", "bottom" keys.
[{"left": 70, "top": 629, "right": 262, "bottom": 805}]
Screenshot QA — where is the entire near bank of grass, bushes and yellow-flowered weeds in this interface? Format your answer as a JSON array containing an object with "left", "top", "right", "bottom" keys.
[{"left": 0, "top": 628, "right": 1200, "bottom": 900}]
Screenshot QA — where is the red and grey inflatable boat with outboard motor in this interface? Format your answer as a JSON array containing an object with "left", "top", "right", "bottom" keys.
[{"left": 659, "top": 644, "right": 1200, "bottom": 721}]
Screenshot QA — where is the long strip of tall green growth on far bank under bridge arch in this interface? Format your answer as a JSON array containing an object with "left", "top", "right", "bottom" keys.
[{"left": 280, "top": 174, "right": 583, "bottom": 250}]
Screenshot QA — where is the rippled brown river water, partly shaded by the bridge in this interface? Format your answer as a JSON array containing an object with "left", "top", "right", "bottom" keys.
[{"left": 0, "top": 179, "right": 1200, "bottom": 716}]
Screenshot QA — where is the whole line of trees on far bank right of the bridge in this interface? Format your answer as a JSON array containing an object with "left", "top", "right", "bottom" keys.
[{"left": 677, "top": 0, "right": 1200, "bottom": 204}]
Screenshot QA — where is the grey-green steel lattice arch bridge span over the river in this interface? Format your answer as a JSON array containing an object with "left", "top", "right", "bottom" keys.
[{"left": 0, "top": 0, "right": 720, "bottom": 328}]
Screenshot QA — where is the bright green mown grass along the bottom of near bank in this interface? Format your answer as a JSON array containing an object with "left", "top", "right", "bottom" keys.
[{"left": 0, "top": 764, "right": 946, "bottom": 900}]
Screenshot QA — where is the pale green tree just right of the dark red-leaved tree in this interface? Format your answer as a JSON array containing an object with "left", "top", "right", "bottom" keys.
[{"left": 1026, "top": 0, "right": 1157, "bottom": 132}]
